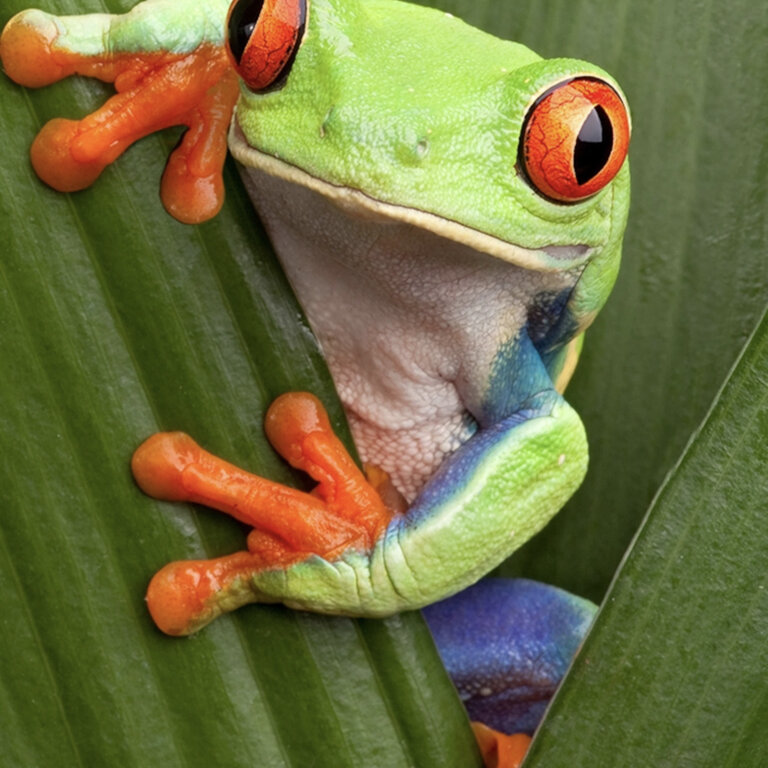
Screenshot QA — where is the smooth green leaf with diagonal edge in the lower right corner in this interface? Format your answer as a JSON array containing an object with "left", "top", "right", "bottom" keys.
[{"left": 525, "top": 308, "right": 768, "bottom": 768}]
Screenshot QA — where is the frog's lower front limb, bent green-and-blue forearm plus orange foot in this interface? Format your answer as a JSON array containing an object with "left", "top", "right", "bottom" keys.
[{"left": 133, "top": 328, "right": 587, "bottom": 634}]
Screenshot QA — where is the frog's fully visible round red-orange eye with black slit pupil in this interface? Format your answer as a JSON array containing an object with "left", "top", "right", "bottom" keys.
[{"left": 519, "top": 77, "right": 629, "bottom": 203}]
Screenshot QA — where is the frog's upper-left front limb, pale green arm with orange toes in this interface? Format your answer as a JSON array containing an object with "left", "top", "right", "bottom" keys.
[{"left": 0, "top": 0, "right": 238, "bottom": 223}]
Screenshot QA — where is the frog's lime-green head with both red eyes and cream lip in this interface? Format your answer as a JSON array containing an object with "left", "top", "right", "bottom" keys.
[{"left": 228, "top": 0, "right": 630, "bottom": 282}]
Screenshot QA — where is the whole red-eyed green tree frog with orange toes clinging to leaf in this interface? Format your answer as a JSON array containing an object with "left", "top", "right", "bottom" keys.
[{"left": 0, "top": 0, "right": 630, "bottom": 760}]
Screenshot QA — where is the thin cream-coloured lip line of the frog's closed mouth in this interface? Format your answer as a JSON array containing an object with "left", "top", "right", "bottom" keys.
[{"left": 229, "top": 120, "right": 595, "bottom": 272}]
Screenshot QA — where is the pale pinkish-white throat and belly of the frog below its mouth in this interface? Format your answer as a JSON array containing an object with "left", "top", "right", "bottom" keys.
[{"left": 237, "top": 168, "right": 576, "bottom": 499}]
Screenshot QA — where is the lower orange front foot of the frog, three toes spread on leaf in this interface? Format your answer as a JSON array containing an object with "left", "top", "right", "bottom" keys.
[{"left": 132, "top": 393, "right": 392, "bottom": 635}]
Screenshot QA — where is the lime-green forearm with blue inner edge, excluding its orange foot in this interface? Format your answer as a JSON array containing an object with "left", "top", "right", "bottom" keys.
[{"left": 253, "top": 396, "right": 587, "bottom": 616}]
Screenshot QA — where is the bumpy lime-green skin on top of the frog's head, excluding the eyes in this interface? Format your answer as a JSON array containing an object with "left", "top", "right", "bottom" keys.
[{"left": 238, "top": 0, "right": 628, "bottom": 268}]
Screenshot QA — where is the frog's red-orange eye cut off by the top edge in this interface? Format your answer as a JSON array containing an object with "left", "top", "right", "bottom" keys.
[{"left": 227, "top": 0, "right": 307, "bottom": 92}]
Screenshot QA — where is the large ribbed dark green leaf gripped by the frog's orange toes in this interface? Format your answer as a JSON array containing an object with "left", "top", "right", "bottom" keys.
[{"left": 0, "top": 2, "right": 479, "bottom": 768}]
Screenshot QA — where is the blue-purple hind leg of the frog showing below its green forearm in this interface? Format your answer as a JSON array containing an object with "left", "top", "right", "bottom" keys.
[{"left": 422, "top": 579, "right": 597, "bottom": 734}]
